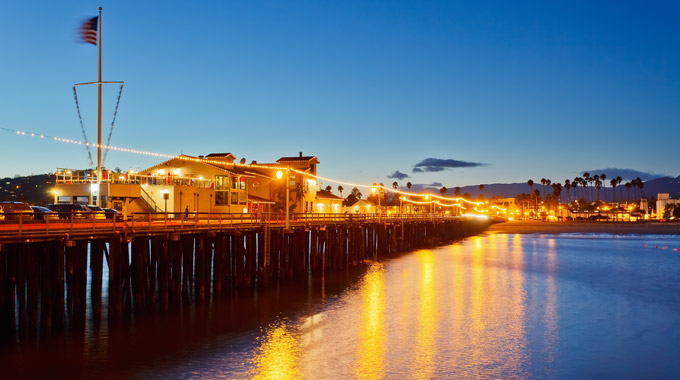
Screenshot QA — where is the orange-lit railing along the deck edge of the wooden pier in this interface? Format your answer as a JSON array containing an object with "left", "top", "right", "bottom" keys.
[{"left": 0, "top": 212, "right": 478, "bottom": 243}]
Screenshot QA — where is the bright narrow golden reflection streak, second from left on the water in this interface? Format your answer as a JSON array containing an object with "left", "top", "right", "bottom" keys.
[{"left": 353, "top": 264, "right": 387, "bottom": 379}]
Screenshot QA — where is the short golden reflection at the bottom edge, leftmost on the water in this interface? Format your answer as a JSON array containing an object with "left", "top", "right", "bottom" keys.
[{"left": 252, "top": 324, "right": 302, "bottom": 379}]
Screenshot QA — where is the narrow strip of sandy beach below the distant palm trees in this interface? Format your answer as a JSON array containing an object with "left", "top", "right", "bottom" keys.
[{"left": 487, "top": 220, "right": 680, "bottom": 235}]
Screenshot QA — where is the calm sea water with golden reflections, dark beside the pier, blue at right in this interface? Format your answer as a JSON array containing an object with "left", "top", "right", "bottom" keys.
[{"left": 3, "top": 234, "right": 680, "bottom": 379}]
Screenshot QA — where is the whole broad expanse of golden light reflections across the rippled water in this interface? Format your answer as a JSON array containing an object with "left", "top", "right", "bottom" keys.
[{"left": 247, "top": 234, "right": 559, "bottom": 379}]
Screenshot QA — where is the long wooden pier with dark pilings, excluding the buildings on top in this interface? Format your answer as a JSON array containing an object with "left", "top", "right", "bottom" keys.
[{"left": 0, "top": 215, "right": 490, "bottom": 344}]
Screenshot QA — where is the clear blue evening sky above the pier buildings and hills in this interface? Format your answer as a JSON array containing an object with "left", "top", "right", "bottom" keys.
[{"left": 0, "top": 0, "right": 680, "bottom": 188}]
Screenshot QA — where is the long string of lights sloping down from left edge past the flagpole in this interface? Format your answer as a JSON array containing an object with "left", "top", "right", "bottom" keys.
[{"left": 0, "top": 127, "right": 492, "bottom": 206}]
